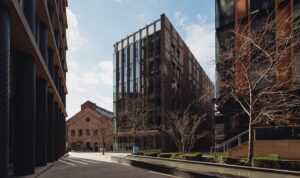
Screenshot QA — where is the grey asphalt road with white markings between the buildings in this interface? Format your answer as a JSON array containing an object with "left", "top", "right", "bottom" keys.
[{"left": 39, "top": 157, "right": 174, "bottom": 178}]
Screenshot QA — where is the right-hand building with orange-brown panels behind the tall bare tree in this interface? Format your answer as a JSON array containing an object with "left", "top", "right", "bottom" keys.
[{"left": 215, "top": 0, "right": 300, "bottom": 143}]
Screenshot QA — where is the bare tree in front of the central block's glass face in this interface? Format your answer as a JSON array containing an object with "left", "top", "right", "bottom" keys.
[{"left": 118, "top": 96, "right": 155, "bottom": 146}]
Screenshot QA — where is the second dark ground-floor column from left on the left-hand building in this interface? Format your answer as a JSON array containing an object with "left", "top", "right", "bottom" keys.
[{"left": 13, "top": 52, "right": 36, "bottom": 176}]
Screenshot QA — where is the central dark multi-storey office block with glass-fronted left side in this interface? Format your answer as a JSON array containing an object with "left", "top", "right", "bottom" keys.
[{"left": 113, "top": 14, "right": 214, "bottom": 151}]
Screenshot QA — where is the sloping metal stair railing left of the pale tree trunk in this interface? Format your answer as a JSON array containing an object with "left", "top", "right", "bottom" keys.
[{"left": 210, "top": 130, "right": 249, "bottom": 155}]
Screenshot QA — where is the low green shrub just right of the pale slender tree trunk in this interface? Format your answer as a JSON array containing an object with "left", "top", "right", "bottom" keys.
[{"left": 252, "top": 154, "right": 280, "bottom": 169}]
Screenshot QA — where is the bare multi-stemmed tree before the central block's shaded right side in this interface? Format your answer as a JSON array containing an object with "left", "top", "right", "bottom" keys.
[{"left": 162, "top": 91, "right": 214, "bottom": 153}]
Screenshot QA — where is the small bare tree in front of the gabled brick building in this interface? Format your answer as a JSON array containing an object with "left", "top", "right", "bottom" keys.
[{"left": 92, "top": 114, "right": 113, "bottom": 155}]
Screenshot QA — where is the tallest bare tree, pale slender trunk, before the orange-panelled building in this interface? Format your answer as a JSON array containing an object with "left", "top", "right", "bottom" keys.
[{"left": 217, "top": 8, "right": 300, "bottom": 162}]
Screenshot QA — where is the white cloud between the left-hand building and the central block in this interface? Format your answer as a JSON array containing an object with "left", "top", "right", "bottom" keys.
[{"left": 67, "top": 8, "right": 113, "bottom": 118}]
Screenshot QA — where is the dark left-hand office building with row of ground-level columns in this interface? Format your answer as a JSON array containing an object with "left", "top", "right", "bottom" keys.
[{"left": 0, "top": 0, "right": 68, "bottom": 178}]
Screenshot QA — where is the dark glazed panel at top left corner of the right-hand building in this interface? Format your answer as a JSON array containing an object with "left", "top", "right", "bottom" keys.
[{"left": 215, "top": 0, "right": 234, "bottom": 28}]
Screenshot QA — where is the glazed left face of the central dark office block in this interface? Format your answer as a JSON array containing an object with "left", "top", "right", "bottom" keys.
[{"left": 114, "top": 20, "right": 161, "bottom": 151}]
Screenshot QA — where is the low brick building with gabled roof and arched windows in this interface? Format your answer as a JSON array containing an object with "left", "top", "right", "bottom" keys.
[{"left": 67, "top": 101, "right": 113, "bottom": 151}]
